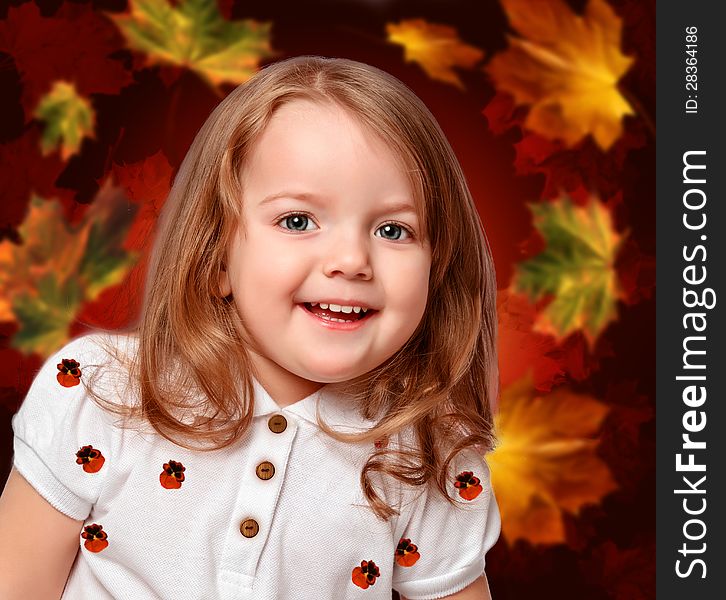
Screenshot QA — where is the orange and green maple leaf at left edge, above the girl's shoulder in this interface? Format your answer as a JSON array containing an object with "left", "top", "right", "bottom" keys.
[{"left": 0, "top": 187, "right": 136, "bottom": 356}]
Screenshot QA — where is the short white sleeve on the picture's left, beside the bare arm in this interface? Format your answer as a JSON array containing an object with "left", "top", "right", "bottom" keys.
[{"left": 12, "top": 335, "right": 122, "bottom": 520}]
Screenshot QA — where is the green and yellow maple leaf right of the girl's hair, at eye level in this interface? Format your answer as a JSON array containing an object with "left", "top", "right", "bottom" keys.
[{"left": 512, "top": 197, "right": 622, "bottom": 345}]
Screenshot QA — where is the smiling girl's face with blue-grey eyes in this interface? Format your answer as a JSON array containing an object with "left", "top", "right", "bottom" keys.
[{"left": 221, "top": 100, "right": 431, "bottom": 404}]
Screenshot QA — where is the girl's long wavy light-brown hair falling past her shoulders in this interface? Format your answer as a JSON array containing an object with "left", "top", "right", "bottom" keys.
[{"left": 96, "top": 56, "right": 499, "bottom": 519}]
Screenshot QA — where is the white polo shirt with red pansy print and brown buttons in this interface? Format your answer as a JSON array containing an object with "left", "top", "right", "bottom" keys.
[{"left": 13, "top": 334, "right": 500, "bottom": 600}]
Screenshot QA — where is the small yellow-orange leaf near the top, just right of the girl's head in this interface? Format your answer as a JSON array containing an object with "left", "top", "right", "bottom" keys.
[{"left": 386, "top": 19, "right": 484, "bottom": 89}]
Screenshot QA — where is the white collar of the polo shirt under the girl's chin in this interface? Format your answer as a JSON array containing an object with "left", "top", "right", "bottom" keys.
[{"left": 252, "top": 378, "right": 376, "bottom": 433}]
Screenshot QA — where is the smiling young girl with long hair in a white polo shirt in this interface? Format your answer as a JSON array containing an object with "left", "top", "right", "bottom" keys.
[{"left": 0, "top": 57, "right": 500, "bottom": 600}]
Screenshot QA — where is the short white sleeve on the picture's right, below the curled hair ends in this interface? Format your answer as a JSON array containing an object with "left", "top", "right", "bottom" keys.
[{"left": 393, "top": 450, "right": 501, "bottom": 600}]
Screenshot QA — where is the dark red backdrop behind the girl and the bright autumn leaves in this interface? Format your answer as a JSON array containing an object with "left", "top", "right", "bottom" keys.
[{"left": 0, "top": 0, "right": 655, "bottom": 600}]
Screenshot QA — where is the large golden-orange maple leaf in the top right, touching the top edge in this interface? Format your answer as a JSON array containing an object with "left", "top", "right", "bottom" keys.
[{"left": 487, "top": 0, "right": 633, "bottom": 150}]
